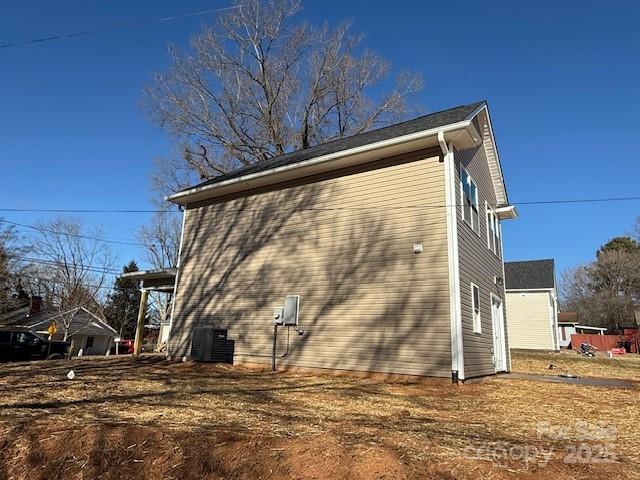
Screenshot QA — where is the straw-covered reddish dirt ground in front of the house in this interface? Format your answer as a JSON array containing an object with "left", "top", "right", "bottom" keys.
[{"left": 0, "top": 353, "right": 640, "bottom": 480}]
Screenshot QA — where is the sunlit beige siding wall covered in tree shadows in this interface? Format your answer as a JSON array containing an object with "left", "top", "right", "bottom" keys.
[{"left": 169, "top": 150, "right": 451, "bottom": 377}]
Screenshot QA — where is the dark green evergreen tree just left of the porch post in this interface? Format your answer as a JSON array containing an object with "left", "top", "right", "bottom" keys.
[{"left": 105, "top": 260, "right": 140, "bottom": 338}]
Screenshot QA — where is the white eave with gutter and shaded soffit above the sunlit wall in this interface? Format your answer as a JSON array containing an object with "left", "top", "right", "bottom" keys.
[{"left": 166, "top": 120, "right": 474, "bottom": 205}]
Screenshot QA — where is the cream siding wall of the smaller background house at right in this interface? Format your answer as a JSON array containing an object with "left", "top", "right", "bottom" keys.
[{"left": 507, "top": 291, "right": 554, "bottom": 350}]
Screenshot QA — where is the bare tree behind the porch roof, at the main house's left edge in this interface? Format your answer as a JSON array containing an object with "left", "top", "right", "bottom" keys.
[{"left": 138, "top": 213, "right": 182, "bottom": 323}]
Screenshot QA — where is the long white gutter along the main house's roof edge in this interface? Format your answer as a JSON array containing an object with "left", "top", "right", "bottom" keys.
[{"left": 165, "top": 120, "right": 473, "bottom": 204}]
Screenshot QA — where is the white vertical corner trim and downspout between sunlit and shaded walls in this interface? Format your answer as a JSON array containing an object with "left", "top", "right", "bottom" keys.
[{"left": 438, "top": 132, "right": 465, "bottom": 380}]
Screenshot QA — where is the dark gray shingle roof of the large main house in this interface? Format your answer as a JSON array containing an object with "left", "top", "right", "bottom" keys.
[{"left": 176, "top": 100, "right": 486, "bottom": 190}]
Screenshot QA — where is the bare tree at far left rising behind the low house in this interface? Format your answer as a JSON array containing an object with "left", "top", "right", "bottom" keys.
[{"left": 31, "top": 218, "right": 114, "bottom": 341}]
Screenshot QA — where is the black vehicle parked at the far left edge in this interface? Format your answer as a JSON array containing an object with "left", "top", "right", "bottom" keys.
[{"left": 0, "top": 329, "right": 69, "bottom": 361}]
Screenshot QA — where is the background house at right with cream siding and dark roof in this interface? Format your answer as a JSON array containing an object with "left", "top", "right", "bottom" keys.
[{"left": 504, "top": 260, "right": 560, "bottom": 350}]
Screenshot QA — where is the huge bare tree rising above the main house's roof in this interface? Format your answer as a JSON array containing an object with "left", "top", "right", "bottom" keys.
[{"left": 145, "top": 0, "right": 423, "bottom": 192}]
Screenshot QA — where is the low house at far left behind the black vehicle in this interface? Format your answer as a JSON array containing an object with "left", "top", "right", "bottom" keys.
[{"left": 0, "top": 304, "right": 116, "bottom": 355}]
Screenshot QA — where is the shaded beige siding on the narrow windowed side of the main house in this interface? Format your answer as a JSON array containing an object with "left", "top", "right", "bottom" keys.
[{"left": 454, "top": 146, "right": 509, "bottom": 378}]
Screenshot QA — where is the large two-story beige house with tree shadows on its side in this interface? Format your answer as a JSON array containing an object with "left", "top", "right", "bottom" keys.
[{"left": 168, "top": 102, "right": 516, "bottom": 381}]
